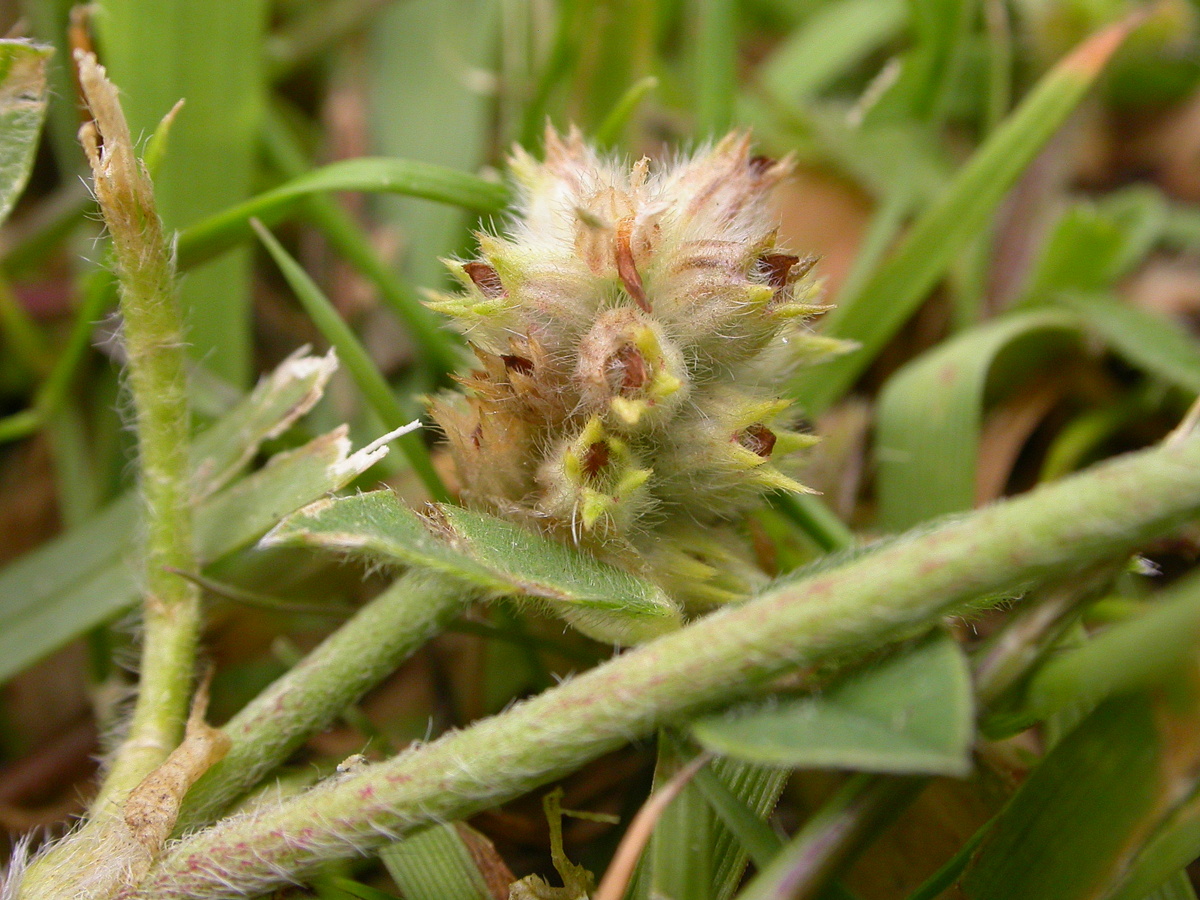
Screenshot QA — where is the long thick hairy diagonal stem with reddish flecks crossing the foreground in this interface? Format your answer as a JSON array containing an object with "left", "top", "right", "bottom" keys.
[{"left": 138, "top": 436, "right": 1200, "bottom": 900}]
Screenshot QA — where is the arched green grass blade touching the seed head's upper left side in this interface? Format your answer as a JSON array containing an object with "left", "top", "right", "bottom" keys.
[{"left": 179, "top": 157, "right": 509, "bottom": 269}]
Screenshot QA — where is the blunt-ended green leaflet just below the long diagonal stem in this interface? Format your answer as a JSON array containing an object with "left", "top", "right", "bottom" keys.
[{"left": 691, "top": 632, "right": 973, "bottom": 775}]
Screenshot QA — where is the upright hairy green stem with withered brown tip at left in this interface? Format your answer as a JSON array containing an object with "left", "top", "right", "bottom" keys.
[{"left": 78, "top": 54, "right": 200, "bottom": 810}]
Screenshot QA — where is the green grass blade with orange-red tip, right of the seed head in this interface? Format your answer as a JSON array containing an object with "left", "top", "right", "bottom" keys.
[{"left": 793, "top": 18, "right": 1129, "bottom": 413}]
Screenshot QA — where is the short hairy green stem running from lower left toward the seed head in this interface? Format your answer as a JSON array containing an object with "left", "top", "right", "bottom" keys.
[{"left": 178, "top": 572, "right": 475, "bottom": 829}]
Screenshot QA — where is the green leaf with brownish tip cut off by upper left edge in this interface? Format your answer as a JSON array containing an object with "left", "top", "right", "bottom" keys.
[{"left": 0, "top": 41, "right": 52, "bottom": 222}]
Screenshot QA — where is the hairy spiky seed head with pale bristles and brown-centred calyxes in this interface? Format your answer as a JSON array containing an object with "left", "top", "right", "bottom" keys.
[{"left": 431, "top": 131, "right": 836, "bottom": 604}]
